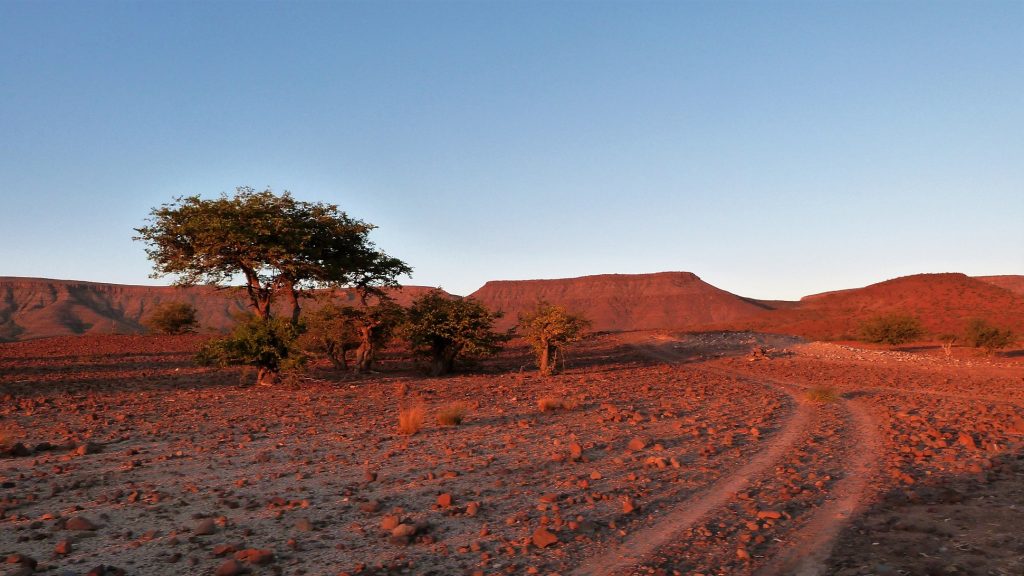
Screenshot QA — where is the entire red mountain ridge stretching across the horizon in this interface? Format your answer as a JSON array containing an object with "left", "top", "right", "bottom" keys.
[{"left": 0, "top": 272, "right": 1024, "bottom": 341}]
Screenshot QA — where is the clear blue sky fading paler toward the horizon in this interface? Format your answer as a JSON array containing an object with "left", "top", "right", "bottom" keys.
[{"left": 0, "top": 1, "right": 1024, "bottom": 298}]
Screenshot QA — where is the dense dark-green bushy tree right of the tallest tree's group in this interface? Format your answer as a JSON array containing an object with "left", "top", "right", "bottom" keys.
[{"left": 404, "top": 290, "right": 509, "bottom": 376}]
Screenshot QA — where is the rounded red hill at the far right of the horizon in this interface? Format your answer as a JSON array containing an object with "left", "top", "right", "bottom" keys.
[{"left": 733, "top": 274, "right": 1024, "bottom": 339}]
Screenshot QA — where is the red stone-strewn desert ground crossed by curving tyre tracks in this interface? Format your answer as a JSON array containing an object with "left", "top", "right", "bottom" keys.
[{"left": 0, "top": 333, "right": 1024, "bottom": 575}]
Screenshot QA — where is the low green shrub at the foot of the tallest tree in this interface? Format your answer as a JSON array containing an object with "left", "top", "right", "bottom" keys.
[{"left": 196, "top": 316, "right": 305, "bottom": 385}]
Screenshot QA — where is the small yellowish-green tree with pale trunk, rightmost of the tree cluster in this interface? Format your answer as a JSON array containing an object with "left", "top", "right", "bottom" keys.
[{"left": 518, "top": 301, "right": 591, "bottom": 376}]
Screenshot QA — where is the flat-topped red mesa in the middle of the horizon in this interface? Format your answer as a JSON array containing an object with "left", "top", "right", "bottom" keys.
[{"left": 470, "top": 272, "right": 764, "bottom": 331}]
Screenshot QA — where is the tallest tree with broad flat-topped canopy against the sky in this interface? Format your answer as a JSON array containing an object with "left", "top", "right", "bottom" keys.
[{"left": 135, "top": 188, "right": 412, "bottom": 383}]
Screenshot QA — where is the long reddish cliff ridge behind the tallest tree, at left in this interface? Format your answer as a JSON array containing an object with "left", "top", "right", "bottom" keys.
[{"left": 0, "top": 277, "right": 430, "bottom": 341}]
